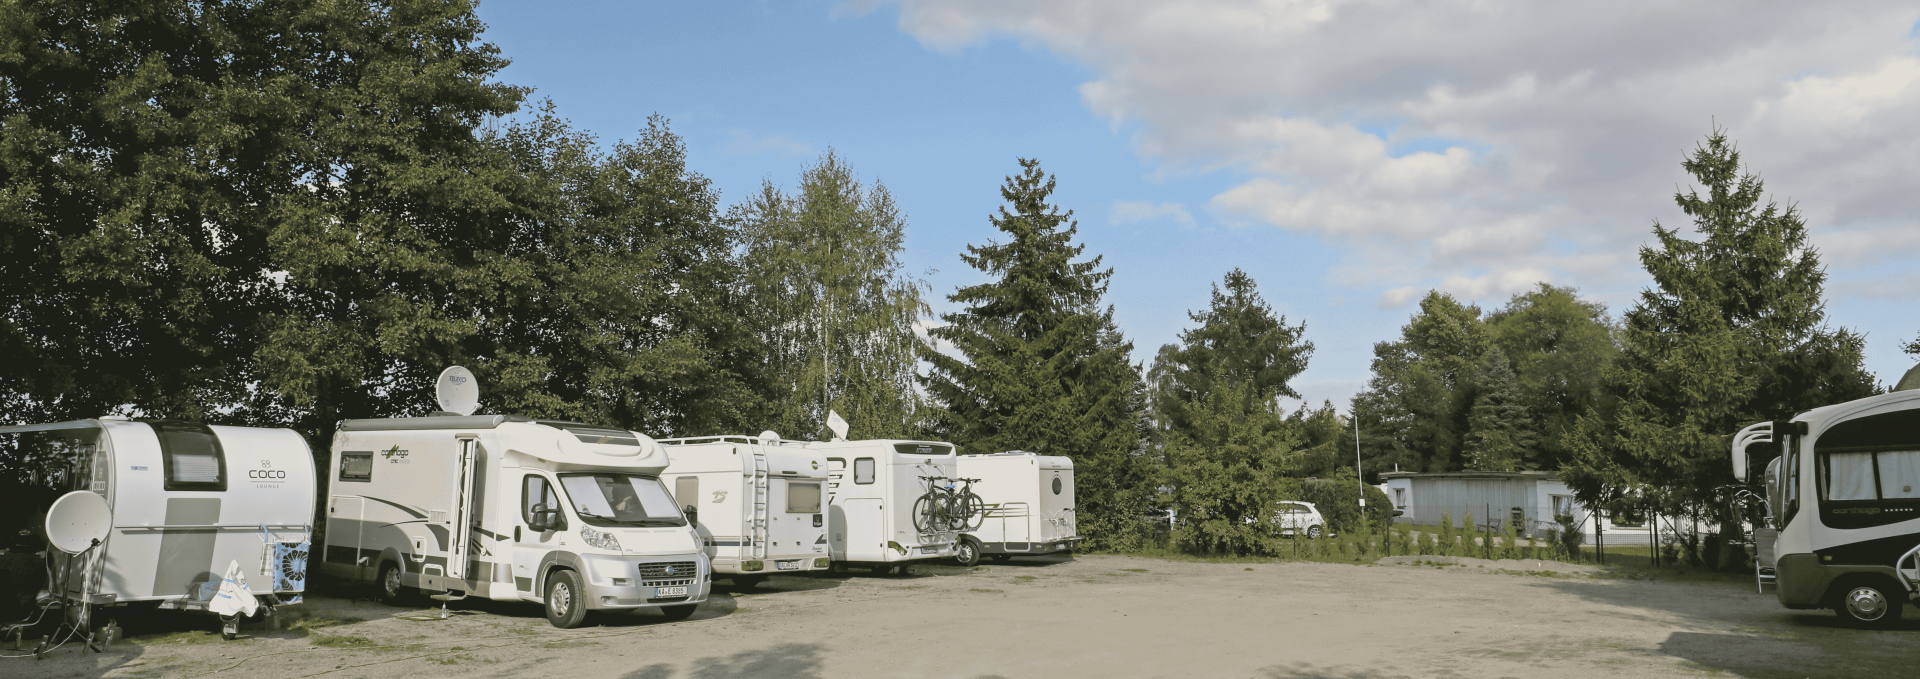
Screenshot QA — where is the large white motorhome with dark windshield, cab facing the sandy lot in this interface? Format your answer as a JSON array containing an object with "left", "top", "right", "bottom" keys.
[{"left": 321, "top": 414, "right": 708, "bottom": 627}]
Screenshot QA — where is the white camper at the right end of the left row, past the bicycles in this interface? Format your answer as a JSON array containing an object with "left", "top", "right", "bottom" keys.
[{"left": 954, "top": 451, "right": 1079, "bottom": 566}]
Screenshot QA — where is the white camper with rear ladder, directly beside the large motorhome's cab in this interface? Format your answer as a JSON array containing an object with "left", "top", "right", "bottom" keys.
[{"left": 660, "top": 433, "right": 829, "bottom": 587}]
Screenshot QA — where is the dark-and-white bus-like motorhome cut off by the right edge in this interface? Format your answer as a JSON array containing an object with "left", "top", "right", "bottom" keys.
[{"left": 1732, "top": 389, "right": 1920, "bottom": 627}]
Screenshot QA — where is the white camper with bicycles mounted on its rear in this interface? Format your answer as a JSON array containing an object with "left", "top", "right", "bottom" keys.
[{"left": 803, "top": 439, "right": 958, "bottom": 575}]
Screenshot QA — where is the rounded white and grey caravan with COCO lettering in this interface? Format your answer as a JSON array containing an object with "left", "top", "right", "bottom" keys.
[{"left": 0, "top": 418, "right": 315, "bottom": 639}]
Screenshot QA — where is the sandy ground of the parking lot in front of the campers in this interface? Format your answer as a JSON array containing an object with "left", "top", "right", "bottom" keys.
[{"left": 0, "top": 556, "right": 1920, "bottom": 679}]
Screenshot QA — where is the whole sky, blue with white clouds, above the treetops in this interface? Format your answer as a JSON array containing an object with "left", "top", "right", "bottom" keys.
[{"left": 478, "top": 0, "right": 1920, "bottom": 410}]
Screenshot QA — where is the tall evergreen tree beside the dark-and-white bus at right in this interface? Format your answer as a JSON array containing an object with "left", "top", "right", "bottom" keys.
[{"left": 1563, "top": 130, "right": 1874, "bottom": 558}]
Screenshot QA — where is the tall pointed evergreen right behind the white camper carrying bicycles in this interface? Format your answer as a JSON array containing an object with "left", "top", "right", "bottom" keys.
[{"left": 922, "top": 159, "right": 1148, "bottom": 543}]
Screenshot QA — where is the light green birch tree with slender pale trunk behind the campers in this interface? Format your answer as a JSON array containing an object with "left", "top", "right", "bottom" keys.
[{"left": 730, "top": 150, "right": 927, "bottom": 439}]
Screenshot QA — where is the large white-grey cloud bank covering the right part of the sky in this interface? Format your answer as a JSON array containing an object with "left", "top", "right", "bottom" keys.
[{"left": 851, "top": 0, "right": 1920, "bottom": 305}]
